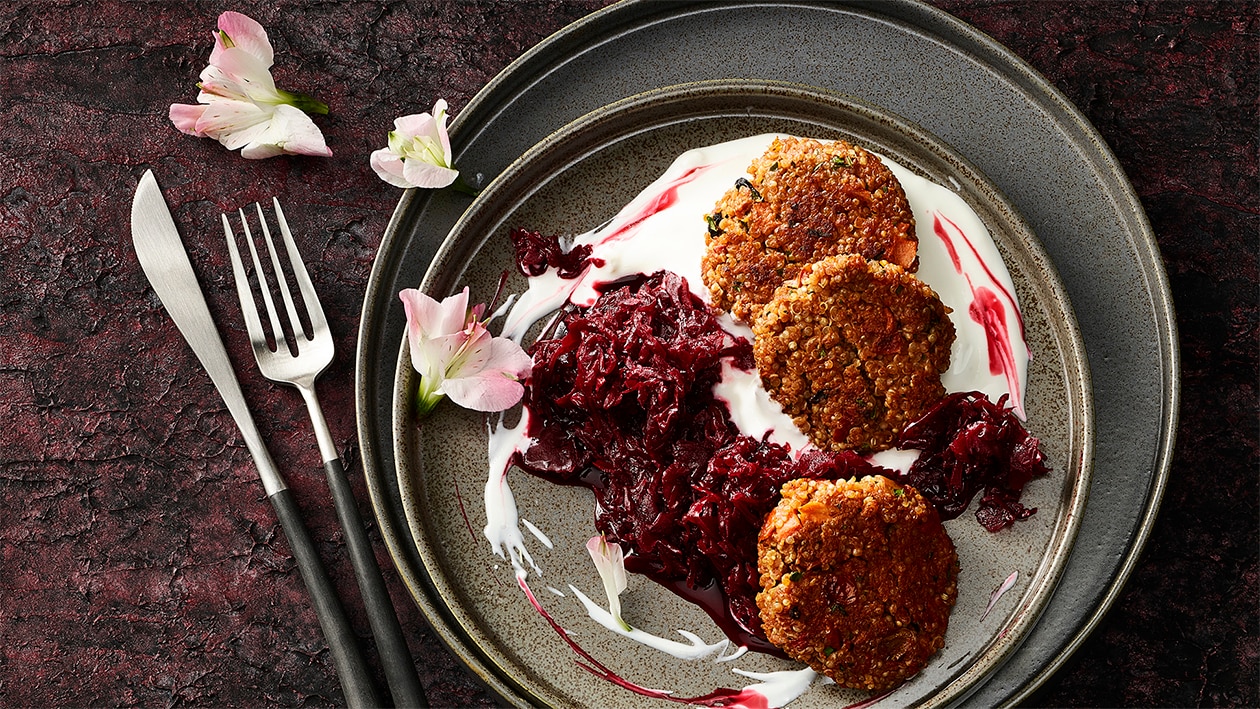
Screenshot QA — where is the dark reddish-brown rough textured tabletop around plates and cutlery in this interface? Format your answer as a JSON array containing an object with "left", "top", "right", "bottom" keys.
[{"left": 0, "top": 0, "right": 1260, "bottom": 706}]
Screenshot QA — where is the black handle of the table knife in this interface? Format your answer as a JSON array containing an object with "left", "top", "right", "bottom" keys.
[{"left": 271, "top": 487, "right": 381, "bottom": 708}]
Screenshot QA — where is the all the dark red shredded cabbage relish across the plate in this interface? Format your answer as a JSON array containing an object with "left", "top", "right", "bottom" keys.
[{"left": 512, "top": 229, "right": 1048, "bottom": 656}]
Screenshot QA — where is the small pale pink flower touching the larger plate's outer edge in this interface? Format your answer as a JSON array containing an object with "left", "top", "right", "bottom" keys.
[{"left": 370, "top": 98, "right": 460, "bottom": 189}]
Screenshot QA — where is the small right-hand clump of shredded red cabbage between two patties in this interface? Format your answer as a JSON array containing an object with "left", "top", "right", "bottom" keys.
[{"left": 895, "top": 392, "right": 1050, "bottom": 531}]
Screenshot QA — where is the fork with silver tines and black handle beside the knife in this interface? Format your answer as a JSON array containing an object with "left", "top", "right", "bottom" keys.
[{"left": 222, "top": 199, "right": 428, "bottom": 706}]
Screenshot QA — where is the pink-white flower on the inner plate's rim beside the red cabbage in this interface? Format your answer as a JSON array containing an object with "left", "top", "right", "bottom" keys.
[{"left": 398, "top": 288, "right": 533, "bottom": 416}]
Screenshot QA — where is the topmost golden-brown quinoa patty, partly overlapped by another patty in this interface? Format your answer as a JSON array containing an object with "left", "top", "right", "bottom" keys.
[{"left": 701, "top": 137, "right": 919, "bottom": 322}]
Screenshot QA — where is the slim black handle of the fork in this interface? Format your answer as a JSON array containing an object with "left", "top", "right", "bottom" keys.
[{"left": 324, "top": 458, "right": 428, "bottom": 708}]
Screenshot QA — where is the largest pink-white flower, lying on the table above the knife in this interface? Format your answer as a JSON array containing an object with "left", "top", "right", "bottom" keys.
[{"left": 170, "top": 11, "right": 333, "bottom": 159}]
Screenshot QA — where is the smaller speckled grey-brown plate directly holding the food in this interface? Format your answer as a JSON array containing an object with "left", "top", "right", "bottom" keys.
[{"left": 393, "top": 82, "right": 1094, "bottom": 709}]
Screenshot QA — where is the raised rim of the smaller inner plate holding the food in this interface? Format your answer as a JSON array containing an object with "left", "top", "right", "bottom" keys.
[{"left": 392, "top": 79, "right": 1095, "bottom": 705}]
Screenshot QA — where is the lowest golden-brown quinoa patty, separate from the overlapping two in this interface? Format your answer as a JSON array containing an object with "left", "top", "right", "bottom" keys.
[{"left": 757, "top": 476, "right": 958, "bottom": 690}]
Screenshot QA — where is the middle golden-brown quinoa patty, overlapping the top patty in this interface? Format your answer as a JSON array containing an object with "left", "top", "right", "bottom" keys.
[{"left": 752, "top": 254, "right": 954, "bottom": 453}]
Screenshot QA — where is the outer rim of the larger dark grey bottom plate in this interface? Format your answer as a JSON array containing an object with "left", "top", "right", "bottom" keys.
[{"left": 355, "top": 0, "right": 1181, "bottom": 703}]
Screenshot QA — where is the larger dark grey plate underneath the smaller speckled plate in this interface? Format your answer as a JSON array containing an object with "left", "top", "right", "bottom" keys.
[{"left": 357, "top": 0, "right": 1179, "bottom": 706}]
